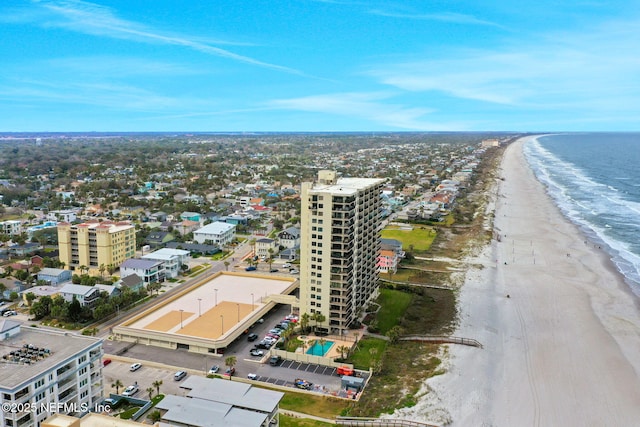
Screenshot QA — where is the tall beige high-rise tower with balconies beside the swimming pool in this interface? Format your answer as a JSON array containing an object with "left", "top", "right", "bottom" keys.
[{"left": 300, "top": 170, "right": 385, "bottom": 333}]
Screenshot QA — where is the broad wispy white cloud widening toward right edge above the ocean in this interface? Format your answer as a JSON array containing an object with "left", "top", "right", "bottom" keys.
[{"left": 367, "top": 17, "right": 640, "bottom": 111}]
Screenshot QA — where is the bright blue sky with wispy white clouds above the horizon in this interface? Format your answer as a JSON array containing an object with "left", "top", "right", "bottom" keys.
[{"left": 0, "top": 0, "right": 640, "bottom": 132}]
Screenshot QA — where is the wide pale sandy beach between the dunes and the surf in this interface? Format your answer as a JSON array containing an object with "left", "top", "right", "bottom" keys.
[{"left": 393, "top": 138, "right": 640, "bottom": 426}]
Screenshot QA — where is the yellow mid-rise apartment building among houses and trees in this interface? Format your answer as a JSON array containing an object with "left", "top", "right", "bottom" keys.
[{"left": 58, "top": 221, "right": 136, "bottom": 271}]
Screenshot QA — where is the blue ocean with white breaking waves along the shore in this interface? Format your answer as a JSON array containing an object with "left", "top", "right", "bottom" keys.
[{"left": 524, "top": 133, "right": 640, "bottom": 297}]
